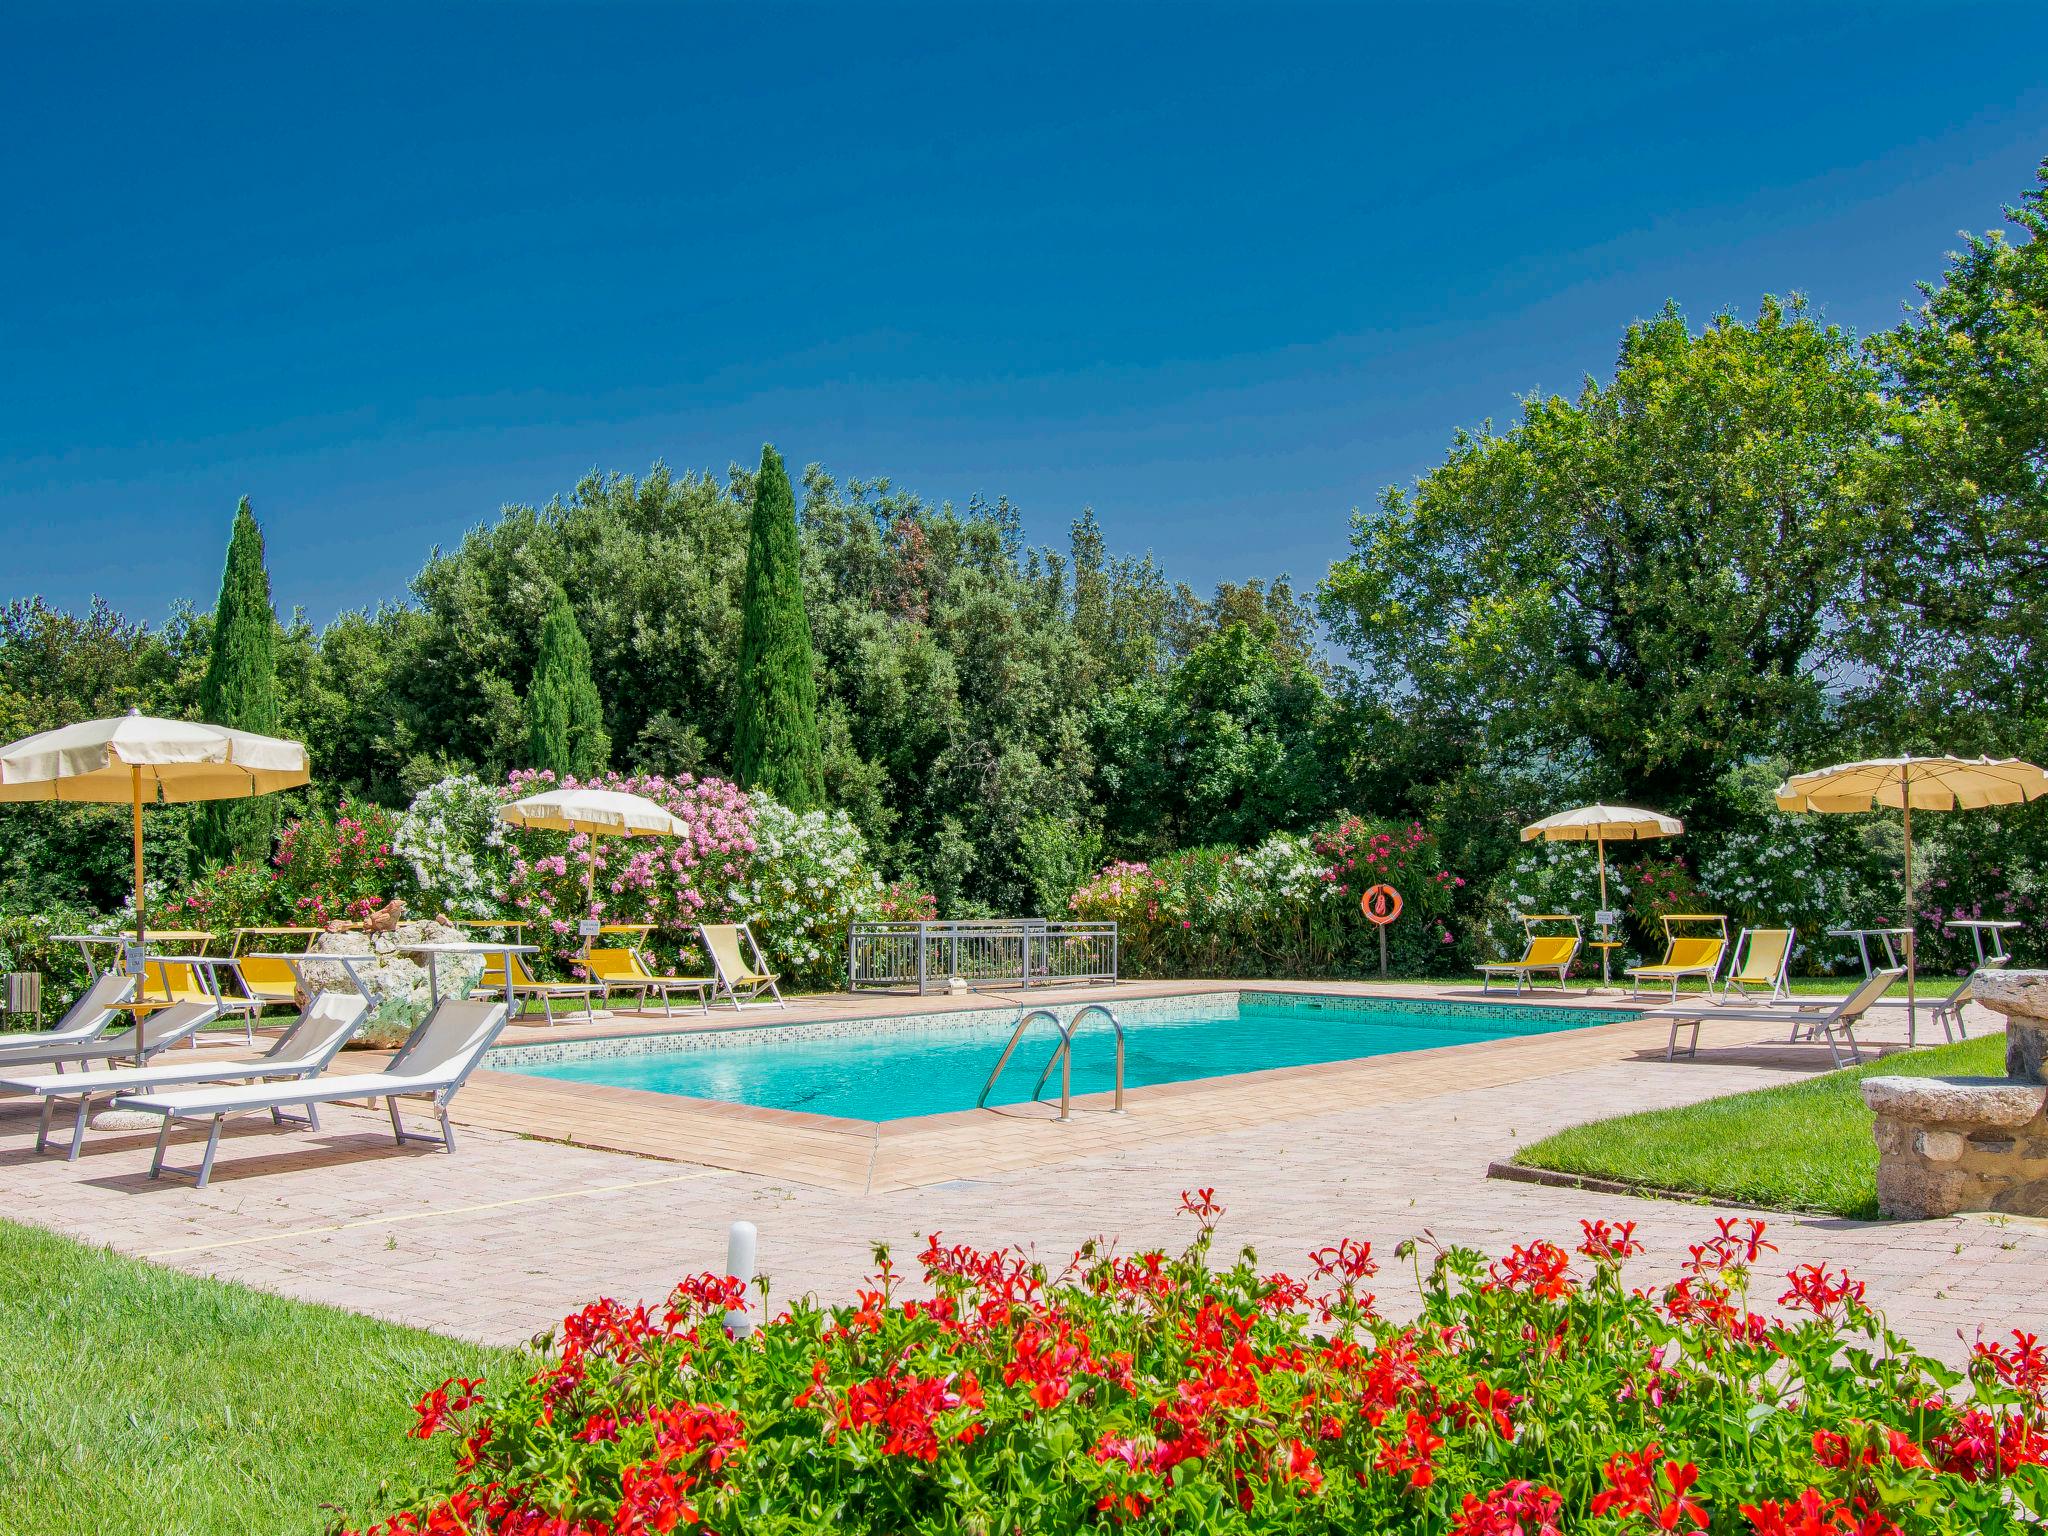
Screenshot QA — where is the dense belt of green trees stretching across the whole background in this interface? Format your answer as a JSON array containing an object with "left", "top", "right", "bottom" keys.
[{"left": 0, "top": 164, "right": 2048, "bottom": 971}]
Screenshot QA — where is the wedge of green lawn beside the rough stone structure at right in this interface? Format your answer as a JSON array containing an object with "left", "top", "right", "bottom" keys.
[{"left": 1513, "top": 1034, "right": 2005, "bottom": 1219}]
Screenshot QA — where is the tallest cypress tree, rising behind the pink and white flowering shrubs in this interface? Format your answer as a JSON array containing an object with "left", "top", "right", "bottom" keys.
[{"left": 733, "top": 444, "right": 825, "bottom": 811}]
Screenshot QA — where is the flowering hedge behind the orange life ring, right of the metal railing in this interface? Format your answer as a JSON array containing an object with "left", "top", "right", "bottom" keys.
[{"left": 1067, "top": 815, "right": 1464, "bottom": 977}]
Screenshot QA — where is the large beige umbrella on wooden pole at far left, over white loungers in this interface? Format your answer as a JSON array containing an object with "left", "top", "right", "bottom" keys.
[{"left": 0, "top": 709, "right": 311, "bottom": 1061}]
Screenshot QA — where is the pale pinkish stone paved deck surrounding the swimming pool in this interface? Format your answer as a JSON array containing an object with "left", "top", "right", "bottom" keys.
[{"left": 0, "top": 983, "right": 2048, "bottom": 1358}]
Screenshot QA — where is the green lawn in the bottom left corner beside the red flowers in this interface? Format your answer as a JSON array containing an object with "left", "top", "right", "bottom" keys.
[{"left": 0, "top": 1221, "right": 518, "bottom": 1536}]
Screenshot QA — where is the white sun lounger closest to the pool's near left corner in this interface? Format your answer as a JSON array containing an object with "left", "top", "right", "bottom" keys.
[{"left": 115, "top": 997, "right": 506, "bottom": 1188}]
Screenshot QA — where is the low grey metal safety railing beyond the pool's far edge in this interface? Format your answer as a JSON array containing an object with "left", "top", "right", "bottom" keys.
[{"left": 846, "top": 918, "right": 1118, "bottom": 993}]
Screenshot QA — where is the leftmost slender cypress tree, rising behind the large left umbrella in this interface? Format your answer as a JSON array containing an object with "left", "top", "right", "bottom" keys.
[{"left": 193, "top": 496, "right": 276, "bottom": 860}]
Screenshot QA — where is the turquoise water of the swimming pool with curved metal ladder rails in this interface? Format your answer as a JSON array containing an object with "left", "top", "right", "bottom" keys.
[{"left": 489, "top": 991, "right": 1636, "bottom": 1120}]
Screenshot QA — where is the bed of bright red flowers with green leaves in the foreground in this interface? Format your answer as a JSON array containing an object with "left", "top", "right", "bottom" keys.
[{"left": 352, "top": 1190, "right": 2048, "bottom": 1536}]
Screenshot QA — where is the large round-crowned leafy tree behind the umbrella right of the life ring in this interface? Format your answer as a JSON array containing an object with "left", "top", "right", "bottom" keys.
[{"left": 1323, "top": 299, "right": 1882, "bottom": 823}]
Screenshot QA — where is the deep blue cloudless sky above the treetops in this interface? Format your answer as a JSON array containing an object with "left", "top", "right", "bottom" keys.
[{"left": 0, "top": 0, "right": 2048, "bottom": 621}]
